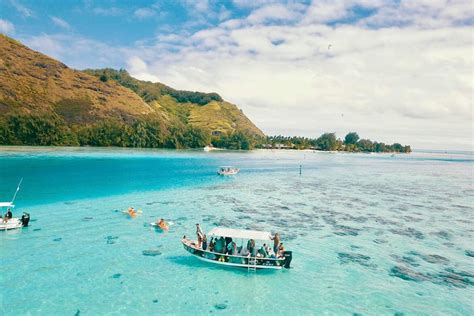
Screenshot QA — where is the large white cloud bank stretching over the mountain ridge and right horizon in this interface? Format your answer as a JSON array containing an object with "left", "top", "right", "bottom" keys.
[{"left": 16, "top": 0, "right": 474, "bottom": 149}]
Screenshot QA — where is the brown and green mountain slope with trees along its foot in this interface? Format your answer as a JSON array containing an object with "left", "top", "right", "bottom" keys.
[{"left": 0, "top": 35, "right": 264, "bottom": 149}]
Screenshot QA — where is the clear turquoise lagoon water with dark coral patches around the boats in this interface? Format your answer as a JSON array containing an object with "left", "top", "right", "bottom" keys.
[{"left": 0, "top": 147, "right": 474, "bottom": 315}]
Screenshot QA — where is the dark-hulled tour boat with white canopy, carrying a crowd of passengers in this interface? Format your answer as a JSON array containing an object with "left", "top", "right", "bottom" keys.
[{"left": 181, "top": 227, "right": 292, "bottom": 270}]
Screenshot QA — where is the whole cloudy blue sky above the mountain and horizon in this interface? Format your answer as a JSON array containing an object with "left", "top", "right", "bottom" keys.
[{"left": 0, "top": 0, "right": 474, "bottom": 150}]
